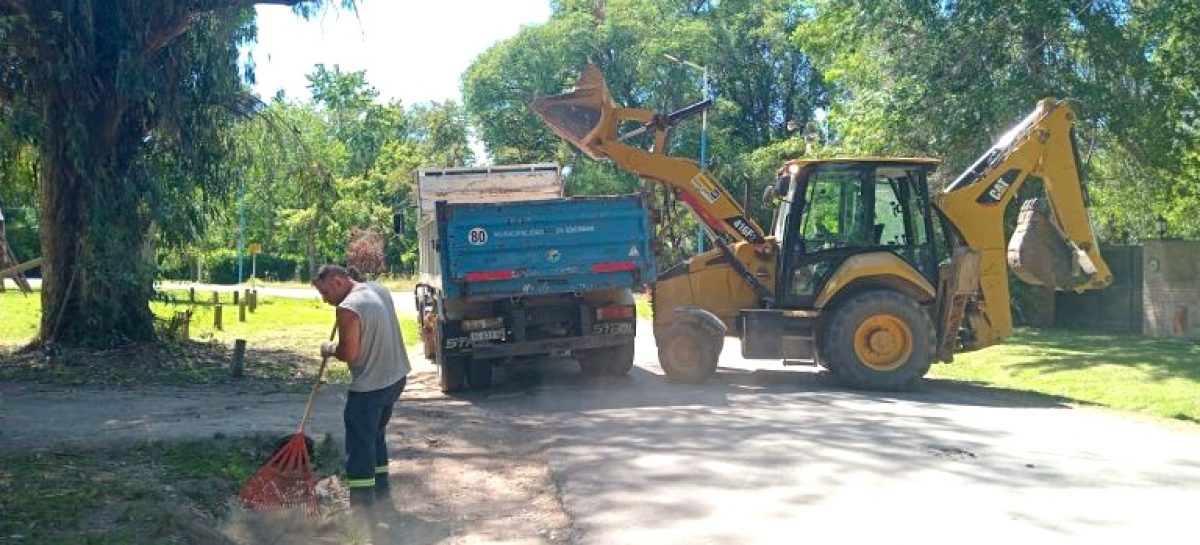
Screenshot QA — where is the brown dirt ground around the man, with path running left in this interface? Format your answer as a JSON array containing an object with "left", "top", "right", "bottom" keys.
[{"left": 0, "top": 359, "right": 572, "bottom": 545}]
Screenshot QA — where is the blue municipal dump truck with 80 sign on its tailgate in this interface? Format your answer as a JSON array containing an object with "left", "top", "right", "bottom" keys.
[{"left": 414, "top": 163, "right": 655, "bottom": 393}]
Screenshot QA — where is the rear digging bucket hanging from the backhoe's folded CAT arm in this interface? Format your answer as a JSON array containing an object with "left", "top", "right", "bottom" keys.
[{"left": 1008, "top": 199, "right": 1096, "bottom": 291}]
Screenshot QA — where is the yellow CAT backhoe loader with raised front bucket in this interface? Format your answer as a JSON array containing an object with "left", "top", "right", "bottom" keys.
[{"left": 533, "top": 65, "right": 1111, "bottom": 389}]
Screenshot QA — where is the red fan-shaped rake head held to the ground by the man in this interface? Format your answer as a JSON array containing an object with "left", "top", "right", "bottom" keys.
[{"left": 238, "top": 433, "right": 318, "bottom": 517}]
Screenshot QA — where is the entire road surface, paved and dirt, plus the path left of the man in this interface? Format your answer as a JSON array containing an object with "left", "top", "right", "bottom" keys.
[{"left": 0, "top": 327, "right": 1200, "bottom": 545}]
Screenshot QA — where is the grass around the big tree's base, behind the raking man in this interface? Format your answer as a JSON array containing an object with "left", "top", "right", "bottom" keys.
[{"left": 0, "top": 291, "right": 420, "bottom": 388}]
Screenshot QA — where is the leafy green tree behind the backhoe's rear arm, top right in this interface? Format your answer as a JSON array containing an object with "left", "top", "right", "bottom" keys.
[{"left": 794, "top": 0, "right": 1200, "bottom": 241}]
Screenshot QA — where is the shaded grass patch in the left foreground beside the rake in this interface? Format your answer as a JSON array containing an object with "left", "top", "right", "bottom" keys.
[{"left": 0, "top": 436, "right": 340, "bottom": 545}]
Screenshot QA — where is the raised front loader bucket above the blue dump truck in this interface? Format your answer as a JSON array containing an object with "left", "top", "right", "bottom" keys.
[{"left": 533, "top": 64, "right": 617, "bottom": 160}]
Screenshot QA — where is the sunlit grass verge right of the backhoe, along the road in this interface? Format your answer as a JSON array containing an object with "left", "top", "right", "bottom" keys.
[{"left": 930, "top": 330, "right": 1200, "bottom": 423}]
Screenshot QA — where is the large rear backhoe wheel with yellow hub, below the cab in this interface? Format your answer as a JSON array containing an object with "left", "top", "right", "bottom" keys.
[{"left": 821, "top": 289, "right": 935, "bottom": 390}]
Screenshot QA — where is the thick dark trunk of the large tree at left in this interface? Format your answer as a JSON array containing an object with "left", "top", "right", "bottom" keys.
[{"left": 38, "top": 60, "right": 154, "bottom": 346}]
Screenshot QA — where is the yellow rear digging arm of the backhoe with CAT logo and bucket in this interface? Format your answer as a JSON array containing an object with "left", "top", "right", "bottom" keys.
[{"left": 936, "top": 100, "right": 1112, "bottom": 351}]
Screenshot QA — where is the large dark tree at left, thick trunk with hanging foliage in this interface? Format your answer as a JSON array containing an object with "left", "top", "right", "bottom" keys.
[{"left": 0, "top": 0, "right": 353, "bottom": 345}]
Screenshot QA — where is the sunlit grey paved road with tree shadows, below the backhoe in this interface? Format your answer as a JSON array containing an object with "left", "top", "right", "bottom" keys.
[{"left": 460, "top": 328, "right": 1200, "bottom": 545}]
